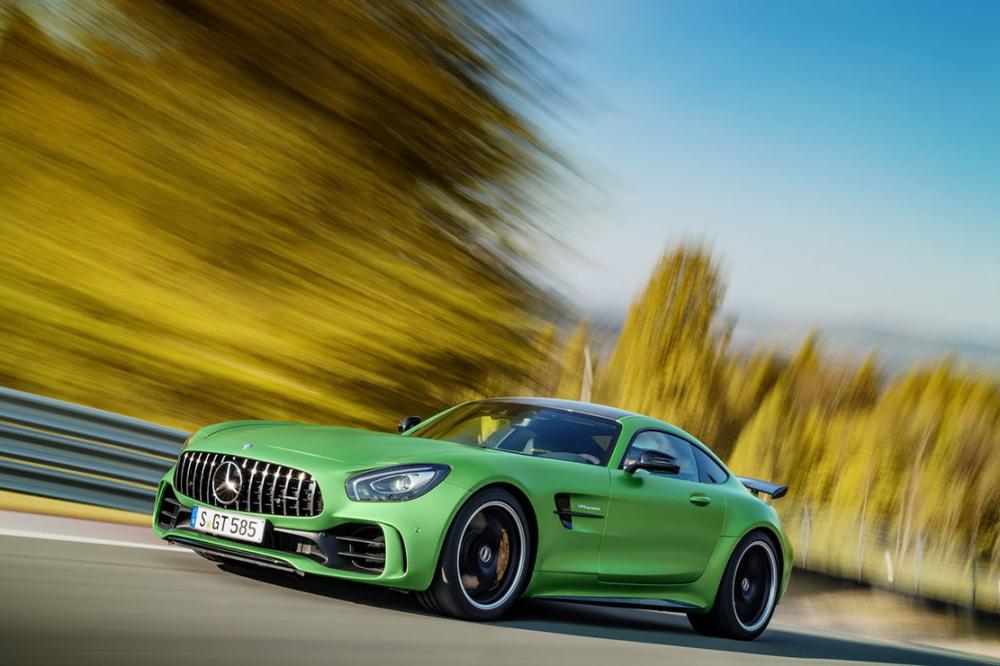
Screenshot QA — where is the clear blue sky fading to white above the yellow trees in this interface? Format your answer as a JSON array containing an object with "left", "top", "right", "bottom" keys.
[{"left": 533, "top": 0, "right": 1000, "bottom": 343}]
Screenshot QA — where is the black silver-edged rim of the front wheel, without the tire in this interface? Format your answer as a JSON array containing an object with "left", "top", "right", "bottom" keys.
[{"left": 458, "top": 502, "right": 524, "bottom": 609}]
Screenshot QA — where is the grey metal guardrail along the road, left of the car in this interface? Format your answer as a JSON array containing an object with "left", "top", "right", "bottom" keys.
[{"left": 0, "top": 388, "right": 188, "bottom": 513}]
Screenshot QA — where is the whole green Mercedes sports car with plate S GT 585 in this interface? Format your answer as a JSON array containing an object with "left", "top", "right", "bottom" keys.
[{"left": 153, "top": 398, "right": 792, "bottom": 640}]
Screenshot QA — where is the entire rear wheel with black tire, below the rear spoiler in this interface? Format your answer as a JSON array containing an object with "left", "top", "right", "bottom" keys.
[{"left": 688, "top": 532, "right": 781, "bottom": 641}]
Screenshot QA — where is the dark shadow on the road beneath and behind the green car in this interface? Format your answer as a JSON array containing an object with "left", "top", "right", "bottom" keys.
[{"left": 219, "top": 564, "right": 990, "bottom": 666}]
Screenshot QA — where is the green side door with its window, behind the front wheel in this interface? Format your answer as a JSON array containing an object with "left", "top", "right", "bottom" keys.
[{"left": 598, "top": 430, "right": 726, "bottom": 585}]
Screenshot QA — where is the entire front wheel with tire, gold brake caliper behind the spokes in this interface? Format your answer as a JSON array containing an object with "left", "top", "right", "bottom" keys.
[{"left": 417, "top": 488, "right": 532, "bottom": 622}]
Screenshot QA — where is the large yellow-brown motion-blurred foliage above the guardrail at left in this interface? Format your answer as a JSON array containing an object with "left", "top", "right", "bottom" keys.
[{"left": 0, "top": 0, "right": 561, "bottom": 427}]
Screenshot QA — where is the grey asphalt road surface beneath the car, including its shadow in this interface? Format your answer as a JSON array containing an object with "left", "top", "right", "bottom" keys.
[{"left": 0, "top": 536, "right": 983, "bottom": 666}]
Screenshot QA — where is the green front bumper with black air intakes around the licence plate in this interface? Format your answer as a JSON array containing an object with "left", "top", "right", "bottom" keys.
[{"left": 153, "top": 469, "right": 468, "bottom": 590}]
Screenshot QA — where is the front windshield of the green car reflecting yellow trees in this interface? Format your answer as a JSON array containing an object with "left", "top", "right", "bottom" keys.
[{"left": 413, "top": 400, "right": 620, "bottom": 465}]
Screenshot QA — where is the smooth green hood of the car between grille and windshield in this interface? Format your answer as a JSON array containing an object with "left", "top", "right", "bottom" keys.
[{"left": 191, "top": 421, "right": 472, "bottom": 470}]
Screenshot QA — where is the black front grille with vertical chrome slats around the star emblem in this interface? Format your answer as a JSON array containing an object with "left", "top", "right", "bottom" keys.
[{"left": 174, "top": 451, "right": 323, "bottom": 517}]
